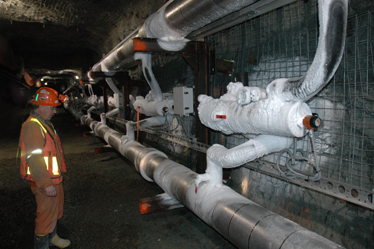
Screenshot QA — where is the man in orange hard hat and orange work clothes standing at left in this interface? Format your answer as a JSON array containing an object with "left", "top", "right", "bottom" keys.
[{"left": 20, "top": 87, "right": 70, "bottom": 249}]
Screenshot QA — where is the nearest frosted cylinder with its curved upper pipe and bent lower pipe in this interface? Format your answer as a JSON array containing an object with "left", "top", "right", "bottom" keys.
[{"left": 195, "top": 0, "right": 348, "bottom": 187}]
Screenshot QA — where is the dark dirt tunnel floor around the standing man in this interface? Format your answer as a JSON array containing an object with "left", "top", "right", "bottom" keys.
[{"left": 0, "top": 100, "right": 235, "bottom": 249}]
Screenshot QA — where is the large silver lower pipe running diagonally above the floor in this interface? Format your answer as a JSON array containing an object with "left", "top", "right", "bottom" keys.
[{"left": 81, "top": 113, "right": 342, "bottom": 249}]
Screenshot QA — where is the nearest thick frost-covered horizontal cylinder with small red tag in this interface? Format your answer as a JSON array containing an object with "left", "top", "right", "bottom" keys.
[{"left": 198, "top": 95, "right": 312, "bottom": 137}]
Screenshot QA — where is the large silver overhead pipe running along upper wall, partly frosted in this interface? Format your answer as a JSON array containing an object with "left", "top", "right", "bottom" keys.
[{"left": 88, "top": 0, "right": 254, "bottom": 73}]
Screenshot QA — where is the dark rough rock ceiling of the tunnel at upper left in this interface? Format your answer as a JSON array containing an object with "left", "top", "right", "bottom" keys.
[{"left": 0, "top": 0, "right": 167, "bottom": 71}]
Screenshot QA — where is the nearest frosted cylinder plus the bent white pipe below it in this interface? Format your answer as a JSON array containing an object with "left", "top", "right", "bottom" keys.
[{"left": 199, "top": 82, "right": 311, "bottom": 187}]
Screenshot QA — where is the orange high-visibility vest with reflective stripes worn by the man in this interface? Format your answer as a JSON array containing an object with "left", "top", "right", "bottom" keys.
[{"left": 20, "top": 114, "right": 66, "bottom": 187}]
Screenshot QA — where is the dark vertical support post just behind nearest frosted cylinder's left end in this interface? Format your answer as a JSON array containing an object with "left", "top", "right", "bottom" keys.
[{"left": 194, "top": 42, "right": 210, "bottom": 174}]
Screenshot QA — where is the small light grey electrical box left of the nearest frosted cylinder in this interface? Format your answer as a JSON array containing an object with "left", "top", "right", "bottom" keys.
[{"left": 173, "top": 86, "right": 193, "bottom": 115}]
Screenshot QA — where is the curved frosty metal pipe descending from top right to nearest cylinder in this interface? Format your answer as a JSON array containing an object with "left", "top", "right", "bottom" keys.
[{"left": 266, "top": 0, "right": 348, "bottom": 101}]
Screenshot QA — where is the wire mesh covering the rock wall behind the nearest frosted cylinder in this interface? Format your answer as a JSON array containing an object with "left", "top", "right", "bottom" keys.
[{"left": 206, "top": 0, "right": 374, "bottom": 200}]
